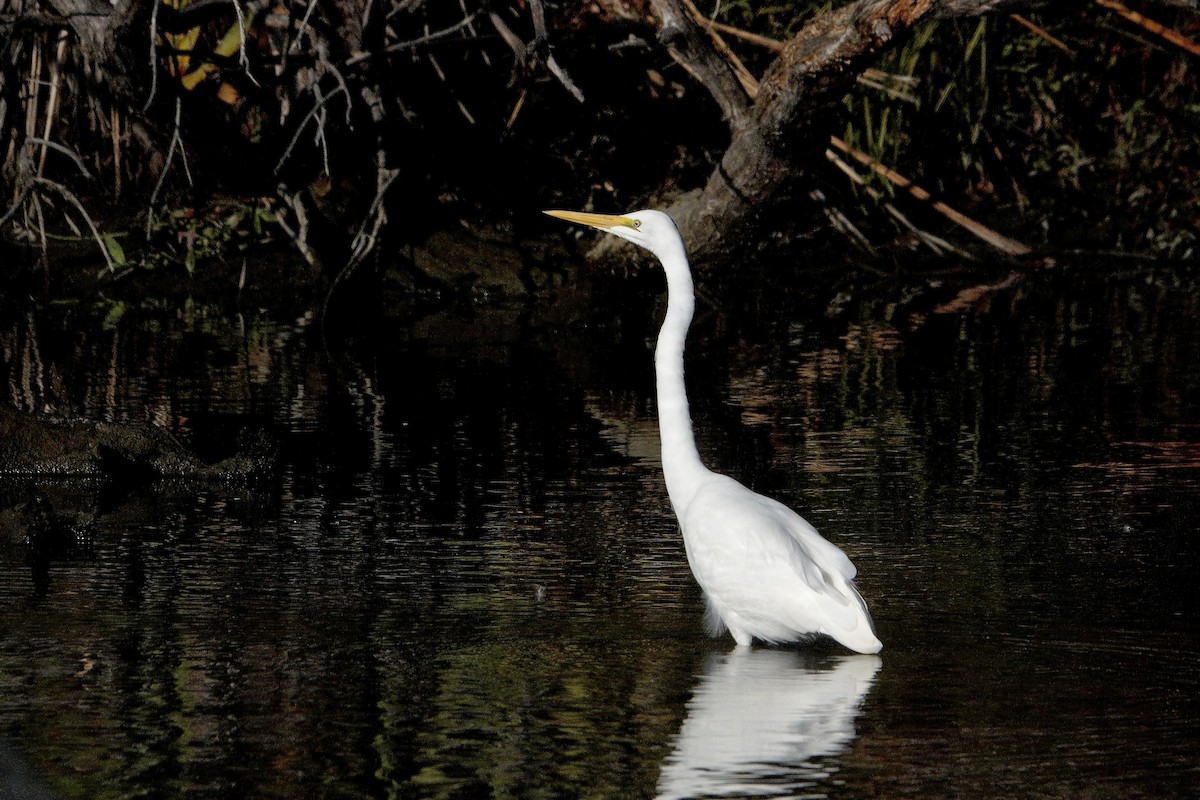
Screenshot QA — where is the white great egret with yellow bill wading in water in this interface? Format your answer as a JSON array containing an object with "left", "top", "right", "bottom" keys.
[{"left": 546, "top": 211, "right": 883, "bottom": 652}]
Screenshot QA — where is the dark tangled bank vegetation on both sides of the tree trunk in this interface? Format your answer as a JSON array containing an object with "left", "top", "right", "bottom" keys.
[{"left": 0, "top": 0, "right": 1200, "bottom": 281}]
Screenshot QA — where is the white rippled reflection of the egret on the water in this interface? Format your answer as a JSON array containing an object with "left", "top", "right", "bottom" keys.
[{"left": 658, "top": 648, "right": 881, "bottom": 800}]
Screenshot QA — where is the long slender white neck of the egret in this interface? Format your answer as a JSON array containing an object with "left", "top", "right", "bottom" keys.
[{"left": 654, "top": 239, "right": 708, "bottom": 515}]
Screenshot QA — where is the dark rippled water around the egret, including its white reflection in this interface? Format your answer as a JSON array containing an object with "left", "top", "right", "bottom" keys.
[{"left": 0, "top": 260, "right": 1200, "bottom": 799}]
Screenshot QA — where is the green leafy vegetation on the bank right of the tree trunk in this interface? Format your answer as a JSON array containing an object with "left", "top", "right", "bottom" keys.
[{"left": 845, "top": 11, "right": 1200, "bottom": 259}]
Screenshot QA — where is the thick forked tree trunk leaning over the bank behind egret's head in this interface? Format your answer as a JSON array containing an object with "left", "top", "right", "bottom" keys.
[{"left": 593, "top": 0, "right": 1066, "bottom": 269}]
